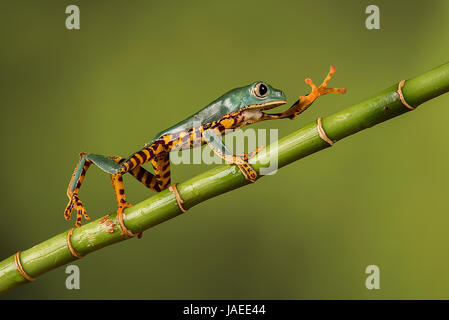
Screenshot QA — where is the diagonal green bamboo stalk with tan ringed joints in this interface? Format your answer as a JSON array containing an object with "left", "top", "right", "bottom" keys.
[{"left": 0, "top": 63, "right": 449, "bottom": 293}]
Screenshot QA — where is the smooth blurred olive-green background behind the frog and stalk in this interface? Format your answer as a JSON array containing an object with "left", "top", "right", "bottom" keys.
[{"left": 0, "top": 0, "right": 449, "bottom": 299}]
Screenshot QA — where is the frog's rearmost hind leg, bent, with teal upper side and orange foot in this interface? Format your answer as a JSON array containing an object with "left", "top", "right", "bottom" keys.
[{"left": 64, "top": 153, "right": 120, "bottom": 227}]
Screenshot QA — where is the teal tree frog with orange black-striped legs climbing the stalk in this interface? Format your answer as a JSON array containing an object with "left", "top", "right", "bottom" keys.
[{"left": 64, "top": 66, "right": 346, "bottom": 227}]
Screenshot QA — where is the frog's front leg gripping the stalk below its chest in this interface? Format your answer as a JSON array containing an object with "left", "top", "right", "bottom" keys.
[{"left": 203, "top": 130, "right": 261, "bottom": 182}]
